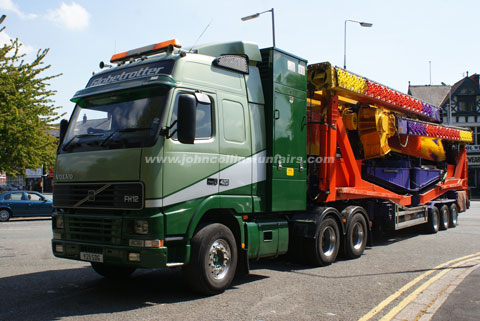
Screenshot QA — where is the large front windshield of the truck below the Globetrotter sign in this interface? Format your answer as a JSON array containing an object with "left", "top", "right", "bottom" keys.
[{"left": 59, "top": 87, "right": 168, "bottom": 153}]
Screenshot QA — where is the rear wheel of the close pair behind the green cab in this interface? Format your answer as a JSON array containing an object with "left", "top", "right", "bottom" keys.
[{"left": 345, "top": 213, "right": 367, "bottom": 259}]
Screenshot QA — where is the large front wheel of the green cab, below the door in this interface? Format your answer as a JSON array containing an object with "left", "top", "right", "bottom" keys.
[{"left": 183, "top": 223, "right": 237, "bottom": 295}]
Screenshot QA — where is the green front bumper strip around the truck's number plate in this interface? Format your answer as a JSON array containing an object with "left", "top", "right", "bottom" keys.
[{"left": 52, "top": 239, "right": 168, "bottom": 268}]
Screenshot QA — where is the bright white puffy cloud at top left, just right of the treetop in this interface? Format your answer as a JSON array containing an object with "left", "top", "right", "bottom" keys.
[{"left": 46, "top": 0, "right": 90, "bottom": 30}]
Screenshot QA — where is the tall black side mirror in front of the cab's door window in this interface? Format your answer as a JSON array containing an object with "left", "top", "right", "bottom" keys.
[{"left": 177, "top": 94, "right": 197, "bottom": 144}]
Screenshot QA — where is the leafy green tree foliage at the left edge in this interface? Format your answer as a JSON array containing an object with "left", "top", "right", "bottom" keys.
[{"left": 0, "top": 39, "right": 61, "bottom": 175}]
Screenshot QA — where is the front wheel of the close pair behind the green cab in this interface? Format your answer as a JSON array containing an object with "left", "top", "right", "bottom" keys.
[{"left": 308, "top": 217, "right": 340, "bottom": 266}]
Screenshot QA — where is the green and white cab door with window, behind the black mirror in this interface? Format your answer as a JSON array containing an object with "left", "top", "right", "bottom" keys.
[{"left": 162, "top": 89, "right": 219, "bottom": 211}]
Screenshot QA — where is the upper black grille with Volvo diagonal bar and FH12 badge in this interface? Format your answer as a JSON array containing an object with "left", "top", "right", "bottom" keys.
[{"left": 53, "top": 183, "right": 143, "bottom": 210}]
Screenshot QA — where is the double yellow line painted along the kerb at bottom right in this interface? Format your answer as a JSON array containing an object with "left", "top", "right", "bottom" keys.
[{"left": 358, "top": 252, "right": 480, "bottom": 321}]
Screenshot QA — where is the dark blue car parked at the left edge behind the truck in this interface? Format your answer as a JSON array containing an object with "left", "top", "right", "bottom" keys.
[{"left": 0, "top": 191, "right": 53, "bottom": 222}]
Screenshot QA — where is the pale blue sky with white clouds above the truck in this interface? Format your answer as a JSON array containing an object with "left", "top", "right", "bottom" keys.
[{"left": 0, "top": 0, "right": 480, "bottom": 116}]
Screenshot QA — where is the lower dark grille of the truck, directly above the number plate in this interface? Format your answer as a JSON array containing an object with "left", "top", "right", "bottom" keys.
[{"left": 65, "top": 216, "right": 122, "bottom": 242}]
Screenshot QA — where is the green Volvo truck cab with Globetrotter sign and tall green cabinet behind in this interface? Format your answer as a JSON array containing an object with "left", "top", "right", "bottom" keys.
[{"left": 52, "top": 41, "right": 307, "bottom": 294}]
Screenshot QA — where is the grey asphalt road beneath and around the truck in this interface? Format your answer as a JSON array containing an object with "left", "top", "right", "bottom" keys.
[{"left": 0, "top": 202, "right": 480, "bottom": 320}]
